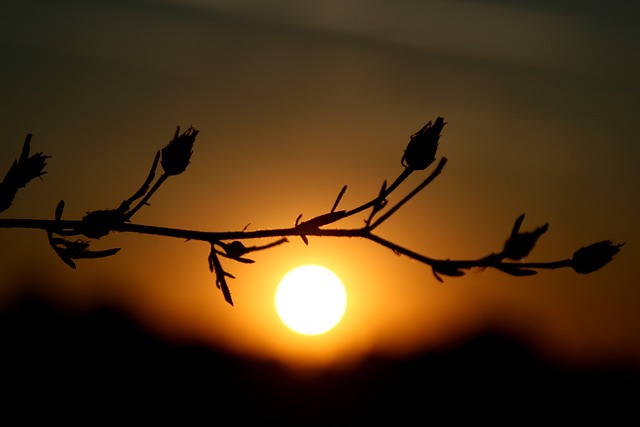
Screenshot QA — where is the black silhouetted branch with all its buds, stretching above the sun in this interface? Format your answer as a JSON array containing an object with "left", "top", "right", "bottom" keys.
[{"left": 0, "top": 117, "right": 624, "bottom": 305}]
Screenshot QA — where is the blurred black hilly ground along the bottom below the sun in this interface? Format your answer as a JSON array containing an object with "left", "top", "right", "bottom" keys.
[{"left": 0, "top": 297, "right": 640, "bottom": 425}]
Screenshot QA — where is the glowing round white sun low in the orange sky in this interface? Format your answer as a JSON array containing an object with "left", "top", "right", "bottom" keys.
[{"left": 275, "top": 265, "right": 347, "bottom": 335}]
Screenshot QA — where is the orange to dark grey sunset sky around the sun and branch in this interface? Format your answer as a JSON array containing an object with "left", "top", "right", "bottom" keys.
[{"left": 0, "top": 0, "right": 640, "bottom": 372}]
